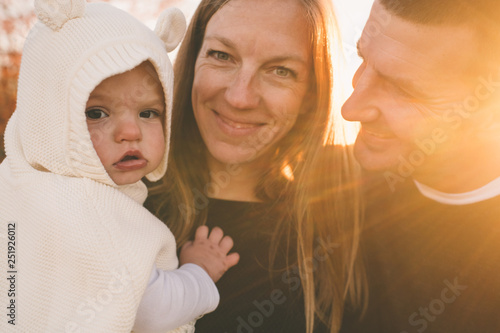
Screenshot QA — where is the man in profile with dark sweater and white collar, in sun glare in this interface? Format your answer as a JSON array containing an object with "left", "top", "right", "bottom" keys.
[{"left": 342, "top": 0, "right": 500, "bottom": 333}]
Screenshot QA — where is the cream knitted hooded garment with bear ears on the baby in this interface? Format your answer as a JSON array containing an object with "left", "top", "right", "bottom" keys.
[{"left": 0, "top": 0, "right": 195, "bottom": 333}]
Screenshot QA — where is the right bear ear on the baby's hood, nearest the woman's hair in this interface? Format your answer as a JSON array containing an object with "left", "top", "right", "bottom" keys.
[{"left": 155, "top": 8, "right": 186, "bottom": 52}]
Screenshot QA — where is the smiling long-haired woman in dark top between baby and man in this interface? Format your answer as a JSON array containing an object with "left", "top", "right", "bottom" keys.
[{"left": 146, "top": 0, "right": 361, "bottom": 332}]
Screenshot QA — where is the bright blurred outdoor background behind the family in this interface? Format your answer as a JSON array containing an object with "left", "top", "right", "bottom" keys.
[{"left": 0, "top": 0, "right": 373, "bottom": 160}]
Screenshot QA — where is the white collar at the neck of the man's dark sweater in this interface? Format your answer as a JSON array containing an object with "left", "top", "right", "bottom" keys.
[{"left": 413, "top": 177, "right": 500, "bottom": 205}]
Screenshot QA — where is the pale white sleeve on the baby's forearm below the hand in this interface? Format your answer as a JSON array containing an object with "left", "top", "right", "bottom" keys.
[{"left": 134, "top": 264, "right": 219, "bottom": 333}]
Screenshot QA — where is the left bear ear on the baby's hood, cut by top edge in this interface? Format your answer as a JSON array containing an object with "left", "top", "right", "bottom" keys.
[{"left": 35, "top": 0, "right": 86, "bottom": 31}]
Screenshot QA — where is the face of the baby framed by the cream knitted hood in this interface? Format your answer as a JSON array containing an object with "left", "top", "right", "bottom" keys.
[{"left": 85, "top": 62, "right": 165, "bottom": 185}]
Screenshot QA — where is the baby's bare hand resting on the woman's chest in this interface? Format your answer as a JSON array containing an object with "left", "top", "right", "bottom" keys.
[{"left": 180, "top": 226, "right": 240, "bottom": 282}]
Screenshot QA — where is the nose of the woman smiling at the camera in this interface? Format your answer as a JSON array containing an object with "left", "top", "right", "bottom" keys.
[{"left": 224, "top": 68, "right": 260, "bottom": 110}]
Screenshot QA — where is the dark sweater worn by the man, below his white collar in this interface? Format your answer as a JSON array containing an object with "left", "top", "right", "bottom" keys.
[{"left": 342, "top": 174, "right": 500, "bottom": 333}]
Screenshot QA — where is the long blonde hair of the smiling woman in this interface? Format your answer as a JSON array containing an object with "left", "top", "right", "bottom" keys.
[{"left": 152, "top": 0, "right": 363, "bottom": 333}]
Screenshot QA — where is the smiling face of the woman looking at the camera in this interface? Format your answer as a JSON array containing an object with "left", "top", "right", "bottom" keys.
[{"left": 192, "top": 0, "right": 312, "bottom": 164}]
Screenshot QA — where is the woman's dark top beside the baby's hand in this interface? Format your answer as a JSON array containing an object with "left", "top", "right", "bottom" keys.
[{"left": 196, "top": 199, "right": 326, "bottom": 333}]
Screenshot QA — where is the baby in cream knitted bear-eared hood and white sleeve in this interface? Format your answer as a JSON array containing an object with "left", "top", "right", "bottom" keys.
[{"left": 0, "top": 0, "right": 239, "bottom": 332}]
